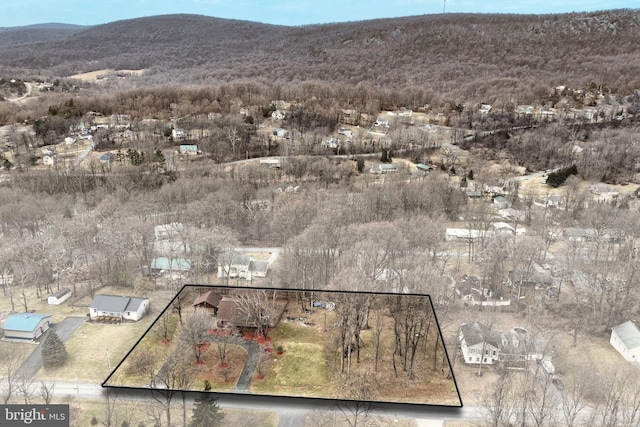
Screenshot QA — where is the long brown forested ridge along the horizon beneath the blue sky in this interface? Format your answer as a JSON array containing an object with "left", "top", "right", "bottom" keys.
[{"left": 0, "top": 10, "right": 640, "bottom": 106}]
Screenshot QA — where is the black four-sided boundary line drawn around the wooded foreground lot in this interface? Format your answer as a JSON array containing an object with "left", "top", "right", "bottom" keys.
[{"left": 101, "top": 284, "right": 464, "bottom": 409}]
